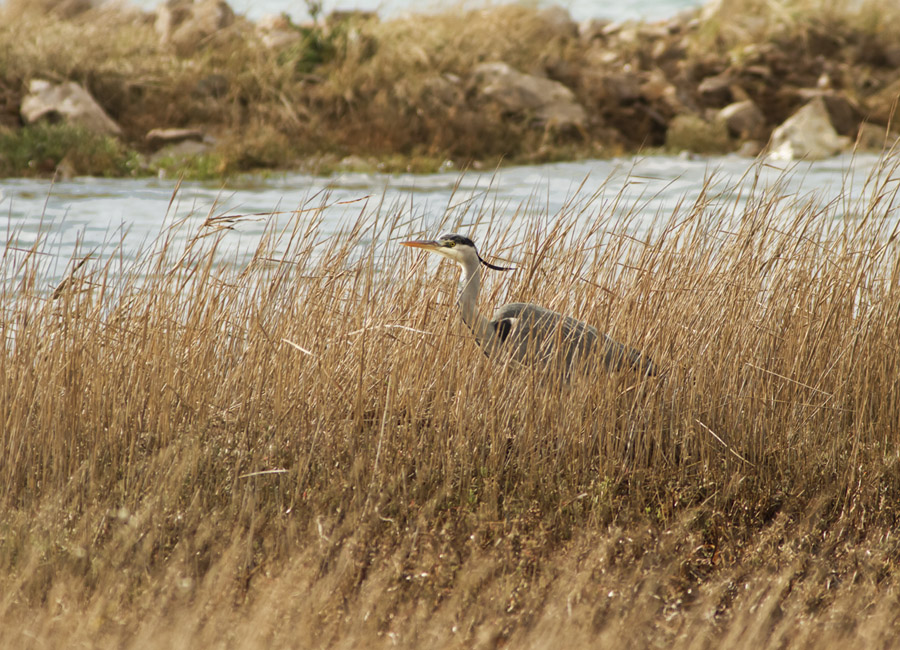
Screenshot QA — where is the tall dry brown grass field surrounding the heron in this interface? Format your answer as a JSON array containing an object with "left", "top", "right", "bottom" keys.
[{"left": 0, "top": 157, "right": 900, "bottom": 648}]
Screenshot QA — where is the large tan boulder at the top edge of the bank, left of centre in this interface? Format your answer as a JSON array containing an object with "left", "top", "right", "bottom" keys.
[{"left": 155, "top": 0, "right": 234, "bottom": 56}]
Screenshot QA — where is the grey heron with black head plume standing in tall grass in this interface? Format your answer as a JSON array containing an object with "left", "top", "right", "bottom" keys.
[{"left": 400, "top": 234, "right": 656, "bottom": 376}]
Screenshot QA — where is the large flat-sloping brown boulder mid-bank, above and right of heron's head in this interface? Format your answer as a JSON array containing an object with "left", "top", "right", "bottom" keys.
[{"left": 472, "top": 62, "right": 587, "bottom": 130}]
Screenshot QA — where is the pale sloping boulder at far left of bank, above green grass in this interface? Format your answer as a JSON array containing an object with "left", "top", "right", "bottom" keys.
[{"left": 20, "top": 79, "right": 122, "bottom": 135}]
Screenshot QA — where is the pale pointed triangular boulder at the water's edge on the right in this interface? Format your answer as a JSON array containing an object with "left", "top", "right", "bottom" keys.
[{"left": 769, "top": 97, "right": 850, "bottom": 160}]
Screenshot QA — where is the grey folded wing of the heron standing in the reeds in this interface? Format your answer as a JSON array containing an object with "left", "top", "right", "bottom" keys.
[{"left": 491, "top": 303, "right": 655, "bottom": 375}]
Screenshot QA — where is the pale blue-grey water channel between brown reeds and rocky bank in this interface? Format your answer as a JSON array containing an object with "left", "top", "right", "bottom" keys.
[{"left": 0, "top": 155, "right": 900, "bottom": 281}]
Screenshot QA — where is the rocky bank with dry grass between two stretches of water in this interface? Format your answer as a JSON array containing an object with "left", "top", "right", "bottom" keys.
[{"left": 0, "top": 0, "right": 900, "bottom": 178}]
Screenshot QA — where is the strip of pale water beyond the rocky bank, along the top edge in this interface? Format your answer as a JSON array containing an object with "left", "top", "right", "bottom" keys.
[{"left": 125, "top": 0, "right": 703, "bottom": 22}]
